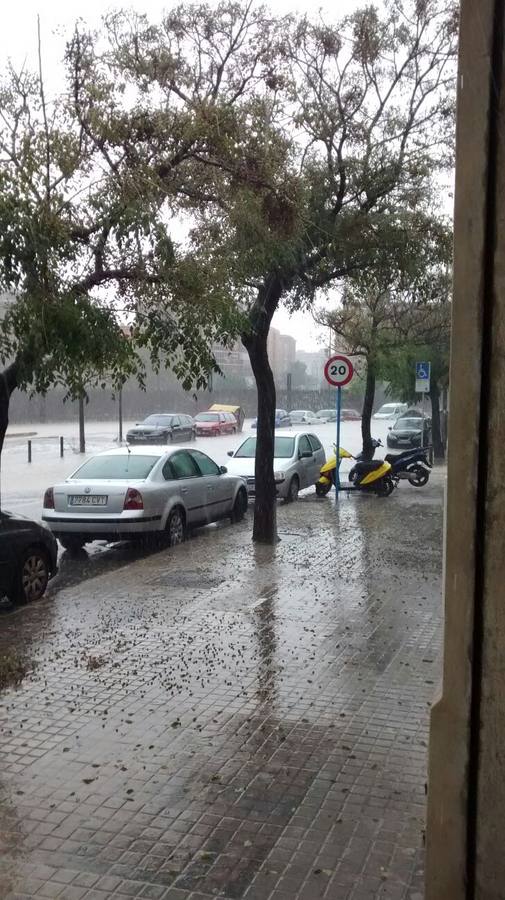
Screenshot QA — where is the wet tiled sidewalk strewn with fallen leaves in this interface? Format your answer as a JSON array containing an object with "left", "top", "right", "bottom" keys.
[{"left": 0, "top": 472, "right": 443, "bottom": 900}]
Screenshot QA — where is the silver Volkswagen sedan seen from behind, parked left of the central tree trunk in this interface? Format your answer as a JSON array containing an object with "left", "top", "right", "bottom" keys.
[{"left": 42, "top": 447, "right": 247, "bottom": 550}]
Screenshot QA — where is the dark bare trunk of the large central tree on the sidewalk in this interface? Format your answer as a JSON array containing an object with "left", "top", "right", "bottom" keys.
[{"left": 242, "top": 276, "right": 283, "bottom": 544}]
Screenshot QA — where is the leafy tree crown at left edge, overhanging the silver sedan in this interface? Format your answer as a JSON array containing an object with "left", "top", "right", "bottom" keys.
[{"left": 0, "top": 26, "right": 244, "bottom": 464}]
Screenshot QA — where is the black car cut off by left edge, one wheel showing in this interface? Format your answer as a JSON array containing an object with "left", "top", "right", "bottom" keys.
[{"left": 0, "top": 512, "right": 58, "bottom": 603}]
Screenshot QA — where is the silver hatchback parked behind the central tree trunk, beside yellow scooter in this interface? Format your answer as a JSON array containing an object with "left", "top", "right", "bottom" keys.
[{"left": 228, "top": 433, "right": 326, "bottom": 501}]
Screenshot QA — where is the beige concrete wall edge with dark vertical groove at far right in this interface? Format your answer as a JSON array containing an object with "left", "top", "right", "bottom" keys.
[{"left": 426, "top": 0, "right": 505, "bottom": 900}]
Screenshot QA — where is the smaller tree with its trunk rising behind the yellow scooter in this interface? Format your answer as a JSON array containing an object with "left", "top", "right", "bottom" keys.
[{"left": 318, "top": 211, "right": 451, "bottom": 459}]
